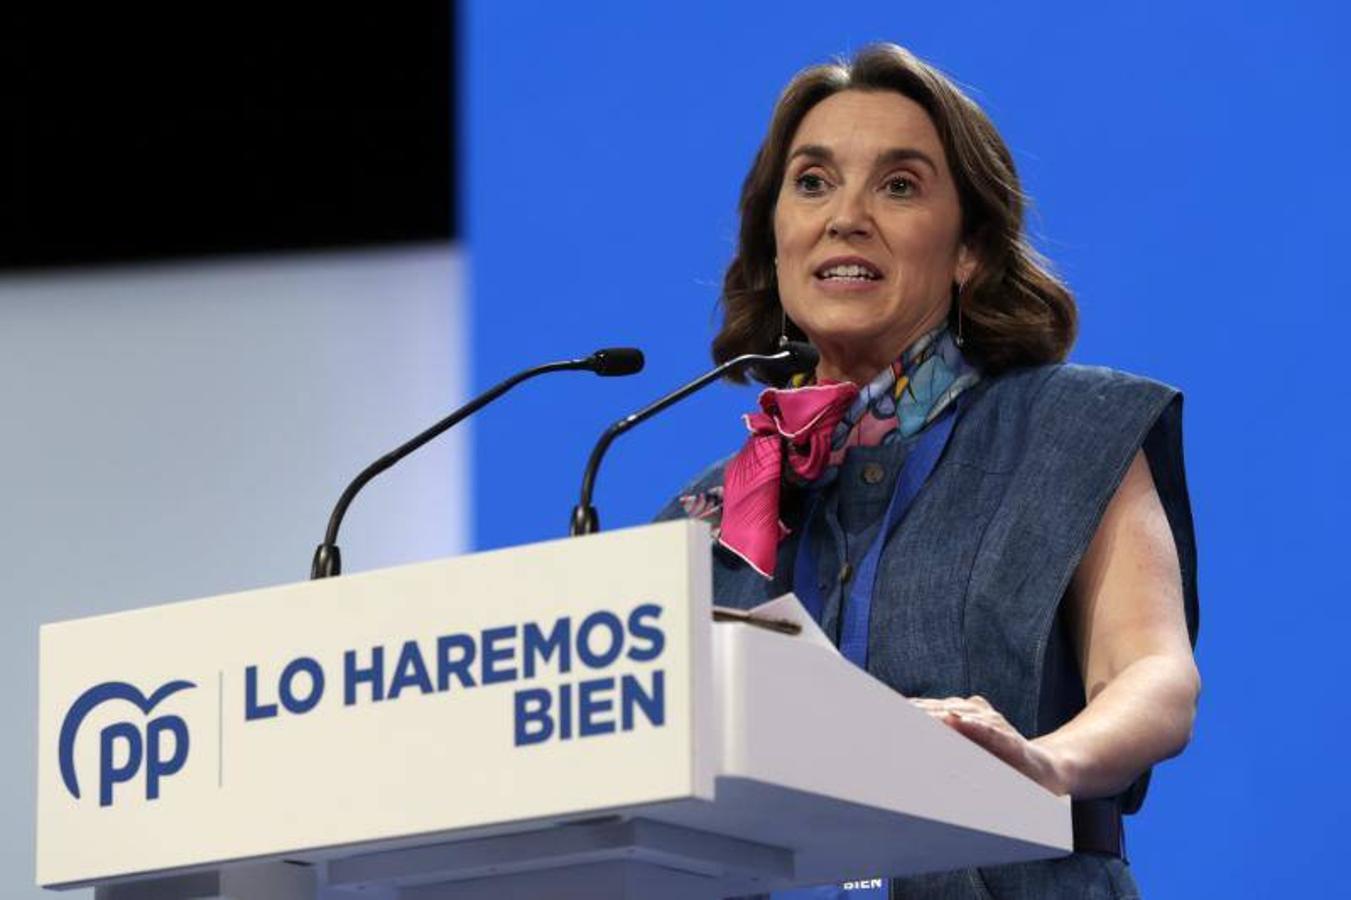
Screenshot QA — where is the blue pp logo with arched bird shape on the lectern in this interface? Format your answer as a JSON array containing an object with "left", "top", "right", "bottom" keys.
[{"left": 58, "top": 681, "right": 197, "bottom": 807}]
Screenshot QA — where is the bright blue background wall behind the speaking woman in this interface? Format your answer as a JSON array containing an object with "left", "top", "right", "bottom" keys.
[{"left": 462, "top": 0, "right": 1351, "bottom": 897}]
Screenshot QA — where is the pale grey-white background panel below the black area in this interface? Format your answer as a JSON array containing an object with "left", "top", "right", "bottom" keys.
[{"left": 0, "top": 245, "right": 470, "bottom": 900}]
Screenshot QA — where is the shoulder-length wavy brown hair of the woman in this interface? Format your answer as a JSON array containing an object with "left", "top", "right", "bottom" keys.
[{"left": 713, "top": 43, "right": 1078, "bottom": 381}]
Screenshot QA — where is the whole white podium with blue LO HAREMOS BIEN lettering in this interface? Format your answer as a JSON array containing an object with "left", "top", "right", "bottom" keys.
[{"left": 36, "top": 522, "right": 1073, "bottom": 900}]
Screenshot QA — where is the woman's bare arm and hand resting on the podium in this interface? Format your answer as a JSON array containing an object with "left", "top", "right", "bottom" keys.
[{"left": 915, "top": 453, "right": 1201, "bottom": 797}]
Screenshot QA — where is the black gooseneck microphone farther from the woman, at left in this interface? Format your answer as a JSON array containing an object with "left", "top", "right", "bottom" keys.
[{"left": 309, "top": 347, "right": 643, "bottom": 580}]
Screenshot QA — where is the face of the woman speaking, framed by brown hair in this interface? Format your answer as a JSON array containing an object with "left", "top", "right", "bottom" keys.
[{"left": 774, "top": 91, "right": 975, "bottom": 382}]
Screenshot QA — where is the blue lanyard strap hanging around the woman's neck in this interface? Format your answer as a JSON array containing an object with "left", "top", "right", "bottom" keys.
[{"left": 793, "top": 399, "right": 965, "bottom": 669}]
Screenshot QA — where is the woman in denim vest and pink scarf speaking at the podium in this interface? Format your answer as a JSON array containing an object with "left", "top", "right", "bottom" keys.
[{"left": 661, "top": 45, "right": 1200, "bottom": 900}]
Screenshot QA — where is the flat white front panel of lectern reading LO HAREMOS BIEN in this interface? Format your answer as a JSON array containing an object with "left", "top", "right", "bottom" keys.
[{"left": 38, "top": 523, "right": 717, "bottom": 885}]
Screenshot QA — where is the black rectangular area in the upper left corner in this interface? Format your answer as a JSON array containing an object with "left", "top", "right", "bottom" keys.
[{"left": 0, "top": 3, "right": 457, "bottom": 269}]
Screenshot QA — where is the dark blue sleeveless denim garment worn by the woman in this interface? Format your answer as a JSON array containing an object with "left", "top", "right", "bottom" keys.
[{"left": 658, "top": 365, "right": 1198, "bottom": 900}]
